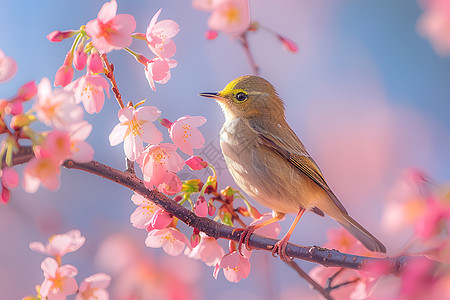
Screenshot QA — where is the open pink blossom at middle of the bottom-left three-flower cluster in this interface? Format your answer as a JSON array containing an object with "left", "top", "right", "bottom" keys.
[{"left": 39, "top": 257, "right": 78, "bottom": 300}]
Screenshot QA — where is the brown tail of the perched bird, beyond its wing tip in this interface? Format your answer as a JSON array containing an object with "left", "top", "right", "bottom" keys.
[{"left": 334, "top": 212, "right": 386, "bottom": 253}]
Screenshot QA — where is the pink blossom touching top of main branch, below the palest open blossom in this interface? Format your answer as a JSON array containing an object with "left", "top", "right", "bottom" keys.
[{"left": 137, "top": 143, "right": 184, "bottom": 188}]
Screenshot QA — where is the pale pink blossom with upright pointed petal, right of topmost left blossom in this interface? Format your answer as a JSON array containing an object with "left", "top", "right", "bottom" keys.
[{"left": 146, "top": 9, "right": 180, "bottom": 58}]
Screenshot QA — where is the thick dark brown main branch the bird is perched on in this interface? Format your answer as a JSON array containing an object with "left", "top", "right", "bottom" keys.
[{"left": 7, "top": 147, "right": 410, "bottom": 273}]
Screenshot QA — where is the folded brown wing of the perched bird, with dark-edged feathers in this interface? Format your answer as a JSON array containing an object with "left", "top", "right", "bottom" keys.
[{"left": 250, "top": 120, "right": 347, "bottom": 214}]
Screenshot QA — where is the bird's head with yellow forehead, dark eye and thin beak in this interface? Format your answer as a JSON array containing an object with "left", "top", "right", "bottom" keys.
[{"left": 200, "top": 75, "right": 284, "bottom": 120}]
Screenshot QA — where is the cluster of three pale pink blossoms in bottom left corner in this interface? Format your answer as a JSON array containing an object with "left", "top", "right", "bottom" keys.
[{"left": 24, "top": 230, "right": 111, "bottom": 300}]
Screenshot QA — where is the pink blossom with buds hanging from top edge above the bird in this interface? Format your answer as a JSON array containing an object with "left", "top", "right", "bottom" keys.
[{"left": 192, "top": 0, "right": 298, "bottom": 53}]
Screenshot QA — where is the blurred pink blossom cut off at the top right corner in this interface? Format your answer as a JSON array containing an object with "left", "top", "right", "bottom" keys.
[{"left": 417, "top": 0, "right": 450, "bottom": 56}]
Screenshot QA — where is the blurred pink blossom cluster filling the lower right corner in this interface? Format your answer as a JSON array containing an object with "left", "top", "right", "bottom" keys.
[{"left": 309, "top": 170, "right": 450, "bottom": 300}]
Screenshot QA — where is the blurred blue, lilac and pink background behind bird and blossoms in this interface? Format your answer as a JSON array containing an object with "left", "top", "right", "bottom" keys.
[{"left": 0, "top": 0, "right": 450, "bottom": 299}]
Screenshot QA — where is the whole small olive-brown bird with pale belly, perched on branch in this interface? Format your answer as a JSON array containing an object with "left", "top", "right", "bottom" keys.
[{"left": 199, "top": 75, "right": 386, "bottom": 260}]
